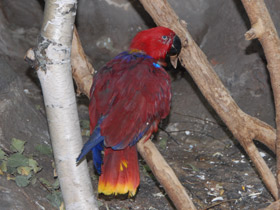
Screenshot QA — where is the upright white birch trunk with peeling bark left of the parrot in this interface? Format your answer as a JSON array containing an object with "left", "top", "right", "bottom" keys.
[{"left": 36, "top": 0, "right": 98, "bottom": 210}]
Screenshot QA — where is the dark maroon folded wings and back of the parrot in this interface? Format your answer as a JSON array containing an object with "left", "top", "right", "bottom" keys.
[{"left": 90, "top": 55, "right": 171, "bottom": 149}]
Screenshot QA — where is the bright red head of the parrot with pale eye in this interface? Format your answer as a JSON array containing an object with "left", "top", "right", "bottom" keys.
[{"left": 130, "top": 26, "right": 181, "bottom": 66}]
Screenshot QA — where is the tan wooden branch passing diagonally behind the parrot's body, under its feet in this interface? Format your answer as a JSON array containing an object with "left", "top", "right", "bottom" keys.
[{"left": 71, "top": 30, "right": 196, "bottom": 210}]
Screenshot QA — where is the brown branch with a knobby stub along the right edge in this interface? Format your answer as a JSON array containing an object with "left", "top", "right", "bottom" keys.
[{"left": 242, "top": 0, "right": 280, "bottom": 199}]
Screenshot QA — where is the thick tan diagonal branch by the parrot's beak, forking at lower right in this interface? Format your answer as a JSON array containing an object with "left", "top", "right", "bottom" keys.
[{"left": 140, "top": 0, "right": 280, "bottom": 199}]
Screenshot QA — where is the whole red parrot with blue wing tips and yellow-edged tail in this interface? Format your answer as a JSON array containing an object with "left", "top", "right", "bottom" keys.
[{"left": 77, "top": 27, "right": 181, "bottom": 196}]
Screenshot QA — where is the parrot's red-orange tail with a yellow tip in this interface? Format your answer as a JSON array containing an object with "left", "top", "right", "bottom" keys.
[{"left": 98, "top": 145, "right": 140, "bottom": 197}]
